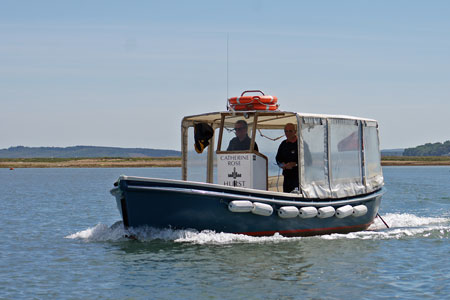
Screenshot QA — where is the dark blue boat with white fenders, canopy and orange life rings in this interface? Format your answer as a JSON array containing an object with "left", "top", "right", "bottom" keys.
[{"left": 111, "top": 91, "right": 385, "bottom": 236}]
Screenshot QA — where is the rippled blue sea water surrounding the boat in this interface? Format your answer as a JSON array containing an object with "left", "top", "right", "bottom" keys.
[{"left": 0, "top": 167, "right": 450, "bottom": 299}]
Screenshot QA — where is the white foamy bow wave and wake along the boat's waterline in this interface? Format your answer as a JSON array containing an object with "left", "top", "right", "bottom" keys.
[{"left": 66, "top": 214, "right": 450, "bottom": 244}]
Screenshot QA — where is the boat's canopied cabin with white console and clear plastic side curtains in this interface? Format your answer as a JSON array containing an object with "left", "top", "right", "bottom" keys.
[{"left": 181, "top": 94, "right": 383, "bottom": 199}]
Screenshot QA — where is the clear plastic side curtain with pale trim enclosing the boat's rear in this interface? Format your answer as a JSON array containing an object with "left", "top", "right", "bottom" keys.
[{"left": 299, "top": 116, "right": 372, "bottom": 199}]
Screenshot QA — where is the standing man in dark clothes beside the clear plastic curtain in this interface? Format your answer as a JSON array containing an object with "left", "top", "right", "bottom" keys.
[{"left": 276, "top": 123, "right": 299, "bottom": 193}]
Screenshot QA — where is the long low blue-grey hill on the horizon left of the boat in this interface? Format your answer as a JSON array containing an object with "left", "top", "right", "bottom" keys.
[{"left": 0, "top": 146, "right": 181, "bottom": 158}]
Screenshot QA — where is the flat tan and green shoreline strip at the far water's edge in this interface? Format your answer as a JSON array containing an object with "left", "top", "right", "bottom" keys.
[{"left": 0, "top": 156, "right": 450, "bottom": 169}]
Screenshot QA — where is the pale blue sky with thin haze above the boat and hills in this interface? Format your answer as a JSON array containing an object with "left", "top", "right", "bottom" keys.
[{"left": 0, "top": 0, "right": 450, "bottom": 150}]
